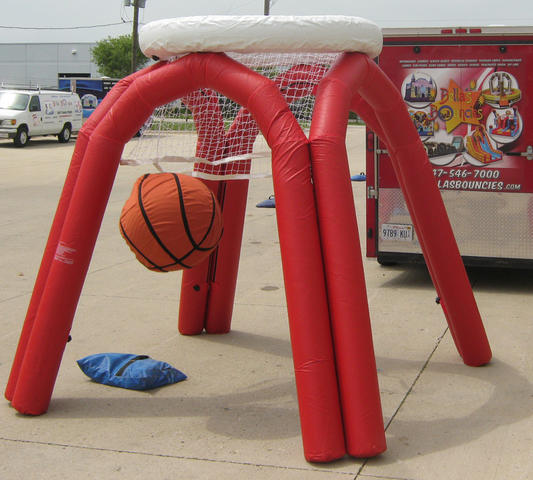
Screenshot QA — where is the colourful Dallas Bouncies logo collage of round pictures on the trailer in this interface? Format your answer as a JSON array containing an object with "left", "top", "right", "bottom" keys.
[{"left": 399, "top": 59, "right": 523, "bottom": 185}]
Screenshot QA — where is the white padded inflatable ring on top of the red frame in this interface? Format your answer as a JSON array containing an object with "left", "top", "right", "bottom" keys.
[{"left": 139, "top": 15, "right": 383, "bottom": 60}]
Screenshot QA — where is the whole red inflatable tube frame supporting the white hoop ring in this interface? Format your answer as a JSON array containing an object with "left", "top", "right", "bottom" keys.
[{"left": 6, "top": 15, "right": 491, "bottom": 462}]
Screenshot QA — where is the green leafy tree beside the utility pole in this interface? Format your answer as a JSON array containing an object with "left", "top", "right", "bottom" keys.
[{"left": 91, "top": 35, "right": 148, "bottom": 78}]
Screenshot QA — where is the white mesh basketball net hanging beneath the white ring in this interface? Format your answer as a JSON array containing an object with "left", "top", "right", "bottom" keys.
[{"left": 122, "top": 53, "right": 339, "bottom": 180}]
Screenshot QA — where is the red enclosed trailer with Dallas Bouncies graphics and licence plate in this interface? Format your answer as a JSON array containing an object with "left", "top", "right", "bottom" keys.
[{"left": 366, "top": 27, "right": 533, "bottom": 268}]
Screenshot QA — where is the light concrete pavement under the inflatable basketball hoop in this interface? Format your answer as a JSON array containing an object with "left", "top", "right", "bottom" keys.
[{"left": 0, "top": 127, "right": 533, "bottom": 480}]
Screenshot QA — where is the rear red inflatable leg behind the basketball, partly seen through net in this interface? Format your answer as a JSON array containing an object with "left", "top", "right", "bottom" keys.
[{"left": 178, "top": 91, "right": 255, "bottom": 335}]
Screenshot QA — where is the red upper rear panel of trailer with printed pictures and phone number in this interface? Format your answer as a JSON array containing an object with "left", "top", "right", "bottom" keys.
[{"left": 379, "top": 41, "right": 533, "bottom": 192}]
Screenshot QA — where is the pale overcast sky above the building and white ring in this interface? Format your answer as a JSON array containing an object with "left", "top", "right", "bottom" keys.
[{"left": 0, "top": 0, "right": 533, "bottom": 43}]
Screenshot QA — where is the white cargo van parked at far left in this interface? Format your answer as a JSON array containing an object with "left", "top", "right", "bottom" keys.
[{"left": 0, "top": 88, "right": 82, "bottom": 147}]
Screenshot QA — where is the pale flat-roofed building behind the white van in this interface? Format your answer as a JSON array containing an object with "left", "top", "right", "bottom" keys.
[{"left": 0, "top": 43, "right": 100, "bottom": 88}]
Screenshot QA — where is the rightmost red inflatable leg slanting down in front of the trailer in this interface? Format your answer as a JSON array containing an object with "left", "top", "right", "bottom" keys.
[{"left": 359, "top": 55, "right": 492, "bottom": 366}]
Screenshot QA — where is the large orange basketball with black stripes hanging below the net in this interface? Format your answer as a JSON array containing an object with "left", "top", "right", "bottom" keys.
[{"left": 120, "top": 173, "right": 222, "bottom": 272}]
